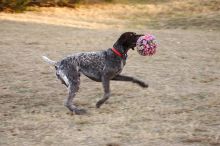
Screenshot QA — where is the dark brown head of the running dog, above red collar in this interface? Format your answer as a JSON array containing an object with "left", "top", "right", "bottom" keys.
[{"left": 115, "top": 32, "right": 143, "bottom": 51}]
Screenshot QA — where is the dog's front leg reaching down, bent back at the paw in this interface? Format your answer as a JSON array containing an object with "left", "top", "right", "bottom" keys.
[{"left": 96, "top": 76, "right": 110, "bottom": 108}]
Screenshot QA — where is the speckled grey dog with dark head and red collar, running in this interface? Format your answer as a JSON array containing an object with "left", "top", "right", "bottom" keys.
[{"left": 43, "top": 32, "right": 148, "bottom": 114}]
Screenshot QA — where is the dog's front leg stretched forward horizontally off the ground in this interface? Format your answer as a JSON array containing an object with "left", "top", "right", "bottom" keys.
[{"left": 112, "top": 75, "right": 148, "bottom": 88}]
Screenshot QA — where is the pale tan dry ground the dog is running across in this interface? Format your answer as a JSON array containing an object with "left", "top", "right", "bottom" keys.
[{"left": 0, "top": 5, "right": 220, "bottom": 146}]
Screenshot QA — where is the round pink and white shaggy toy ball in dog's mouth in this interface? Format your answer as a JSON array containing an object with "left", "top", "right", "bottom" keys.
[{"left": 136, "top": 34, "right": 157, "bottom": 56}]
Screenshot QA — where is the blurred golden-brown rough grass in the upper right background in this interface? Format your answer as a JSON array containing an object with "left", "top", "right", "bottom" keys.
[{"left": 118, "top": 0, "right": 220, "bottom": 30}]
